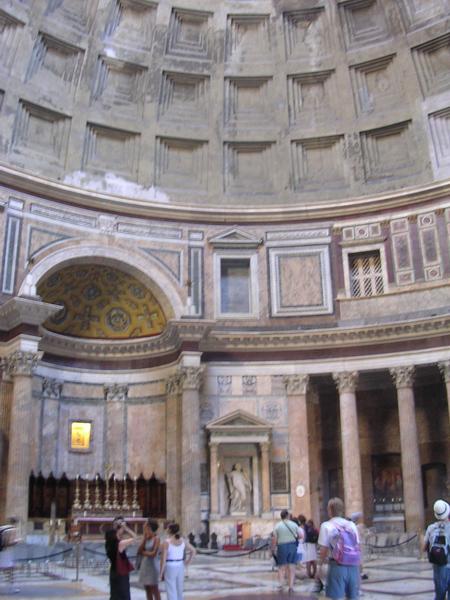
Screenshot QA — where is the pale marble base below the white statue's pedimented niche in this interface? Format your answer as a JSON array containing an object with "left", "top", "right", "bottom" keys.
[{"left": 209, "top": 514, "right": 279, "bottom": 546}]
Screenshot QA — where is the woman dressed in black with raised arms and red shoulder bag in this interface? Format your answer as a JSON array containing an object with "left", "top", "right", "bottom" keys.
[{"left": 105, "top": 519, "right": 137, "bottom": 600}]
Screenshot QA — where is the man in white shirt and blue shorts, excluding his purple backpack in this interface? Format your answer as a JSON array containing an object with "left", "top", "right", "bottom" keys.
[{"left": 318, "top": 498, "right": 360, "bottom": 600}]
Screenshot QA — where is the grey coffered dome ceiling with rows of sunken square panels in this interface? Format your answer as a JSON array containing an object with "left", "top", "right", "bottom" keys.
[{"left": 0, "top": 0, "right": 450, "bottom": 206}]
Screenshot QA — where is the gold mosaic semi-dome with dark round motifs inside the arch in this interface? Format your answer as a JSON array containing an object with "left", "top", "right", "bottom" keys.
[{"left": 38, "top": 265, "right": 166, "bottom": 339}]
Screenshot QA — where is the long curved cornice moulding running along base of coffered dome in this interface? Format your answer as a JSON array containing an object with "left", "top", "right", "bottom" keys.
[{"left": 0, "top": 165, "right": 450, "bottom": 223}]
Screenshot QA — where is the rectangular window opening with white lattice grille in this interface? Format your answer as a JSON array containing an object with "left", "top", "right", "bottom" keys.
[{"left": 348, "top": 250, "right": 384, "bottom": 298}]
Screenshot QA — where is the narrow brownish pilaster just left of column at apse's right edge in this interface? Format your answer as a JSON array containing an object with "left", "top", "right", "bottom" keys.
[{"left": 166, "top": 372, "right": 183, "bottom": 522}]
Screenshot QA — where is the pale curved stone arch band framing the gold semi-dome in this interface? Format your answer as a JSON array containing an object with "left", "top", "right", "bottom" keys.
[{"left": 19, "top": 244, "right": 184, "bottom": 320}]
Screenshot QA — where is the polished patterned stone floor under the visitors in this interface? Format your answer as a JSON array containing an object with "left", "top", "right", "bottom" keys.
[{"left": 0, "top": 556, "right": 433, "bottom": 600}]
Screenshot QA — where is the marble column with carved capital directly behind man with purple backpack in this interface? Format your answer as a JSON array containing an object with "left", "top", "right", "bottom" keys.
[{"left": 333, "top": 371, "right": 364, "bottom": 515}]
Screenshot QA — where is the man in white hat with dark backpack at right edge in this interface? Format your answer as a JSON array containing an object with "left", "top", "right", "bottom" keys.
[{"left": 423, "top": 500, "right": 450, "bottom": 600}]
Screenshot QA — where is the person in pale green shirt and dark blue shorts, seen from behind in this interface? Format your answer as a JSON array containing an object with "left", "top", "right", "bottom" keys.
[{"left": 272, "top": 510, "right": 303, "bottom": 592}]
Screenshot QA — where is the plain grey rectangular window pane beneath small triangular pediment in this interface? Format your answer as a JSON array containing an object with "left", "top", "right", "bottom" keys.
[{"left": 220, "top": 258, "right": 252, "bottom": 314}]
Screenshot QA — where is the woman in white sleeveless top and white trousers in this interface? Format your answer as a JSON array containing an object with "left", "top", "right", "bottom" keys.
[{"left": 161, "top": 523, "right": 196, "bottom": 600}]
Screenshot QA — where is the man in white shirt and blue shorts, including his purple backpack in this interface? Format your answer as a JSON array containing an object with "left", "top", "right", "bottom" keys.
[{"left": 318, "top": 498, "right": 361, "bottom": 600}]
